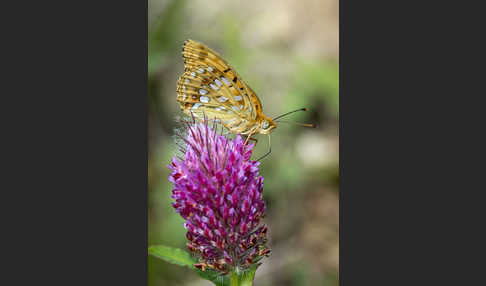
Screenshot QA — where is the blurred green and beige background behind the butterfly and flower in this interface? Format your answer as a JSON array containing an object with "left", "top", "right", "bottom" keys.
[{"left": 148, "top": 0, "right": 339, "bottom": 286}]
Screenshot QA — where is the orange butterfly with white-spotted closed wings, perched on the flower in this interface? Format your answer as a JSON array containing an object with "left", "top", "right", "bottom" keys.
[{"left": 177, "top": 40, "right": 277, "bottom": 137}]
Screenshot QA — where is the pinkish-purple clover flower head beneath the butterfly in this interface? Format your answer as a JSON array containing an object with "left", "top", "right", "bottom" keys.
[{"left": 168, "top": 123, "right": 270, "bottom": 273}]
